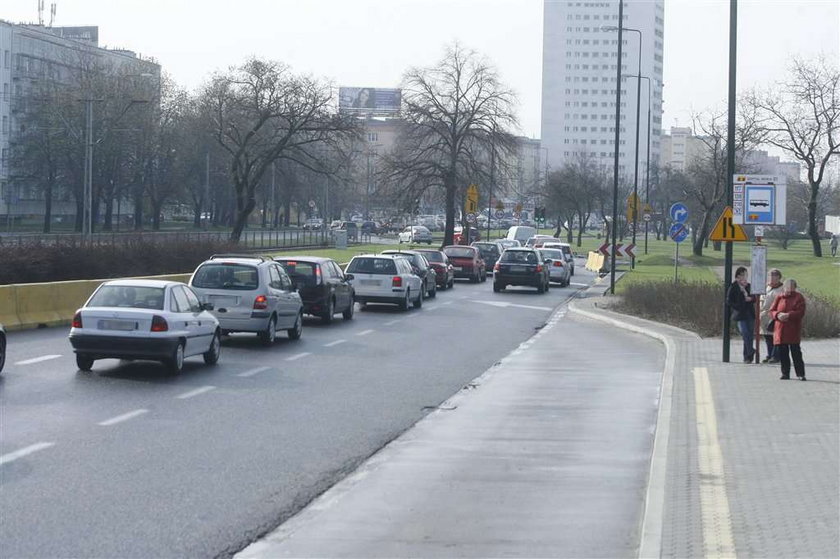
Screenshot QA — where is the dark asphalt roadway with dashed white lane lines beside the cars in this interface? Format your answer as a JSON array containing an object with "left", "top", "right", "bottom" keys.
[{"left": 0, "top": 270, "right": 592, "bottom": 557}]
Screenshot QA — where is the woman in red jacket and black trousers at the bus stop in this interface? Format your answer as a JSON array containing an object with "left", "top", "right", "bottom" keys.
[{"left": 770, "top": 279, "right": 806, "bottom": 380}]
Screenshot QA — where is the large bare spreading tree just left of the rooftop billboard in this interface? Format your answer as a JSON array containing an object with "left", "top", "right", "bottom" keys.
[{"left": 203, "top": 58, "right": 356, "bottom": 242}]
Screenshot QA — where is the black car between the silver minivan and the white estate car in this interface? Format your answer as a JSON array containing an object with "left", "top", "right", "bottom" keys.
[{"left": 274, "top": 256, "right": 356, "bottom": 324}]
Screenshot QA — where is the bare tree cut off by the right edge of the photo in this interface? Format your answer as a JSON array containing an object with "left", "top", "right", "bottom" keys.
[{"left": 746, "top": 59, "right": 840, "bottom": 257}]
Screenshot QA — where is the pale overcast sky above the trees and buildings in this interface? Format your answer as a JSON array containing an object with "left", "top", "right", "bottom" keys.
[{"left": 0, "top": 0, "right": 840, "bottom": 142}]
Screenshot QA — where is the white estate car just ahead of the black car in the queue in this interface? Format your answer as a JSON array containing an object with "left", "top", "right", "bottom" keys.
[{"left": 347, "top": 254, "right": 423, "bottom": 310}]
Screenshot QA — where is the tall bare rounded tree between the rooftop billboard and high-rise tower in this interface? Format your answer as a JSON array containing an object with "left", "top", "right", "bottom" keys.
[{"left": 384, "top": 44, "right": 516, "bottom": 244}]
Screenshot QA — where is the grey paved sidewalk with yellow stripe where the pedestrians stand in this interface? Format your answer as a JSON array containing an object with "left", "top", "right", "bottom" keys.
[{"left": 575, "top": 299, "right": 840, "bottom": 558}]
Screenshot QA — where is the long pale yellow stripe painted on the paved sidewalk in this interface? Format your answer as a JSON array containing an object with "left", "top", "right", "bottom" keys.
[{"left": 692, "top": 367, "right": 735, "bottom": 557}]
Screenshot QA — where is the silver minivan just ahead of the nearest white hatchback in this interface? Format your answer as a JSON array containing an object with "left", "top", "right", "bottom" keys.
[{"left": 189, "top": 254, "right": 303, "bottom": 345}]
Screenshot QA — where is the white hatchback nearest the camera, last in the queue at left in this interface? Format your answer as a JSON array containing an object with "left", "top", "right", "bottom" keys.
[{"left": 70, "top": 279, "right": 221, "bottom": 373}]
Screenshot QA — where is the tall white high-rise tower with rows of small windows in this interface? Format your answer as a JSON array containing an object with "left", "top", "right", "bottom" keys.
[{"left": 541, "top": 0, "right": 665, "bottom": 182}]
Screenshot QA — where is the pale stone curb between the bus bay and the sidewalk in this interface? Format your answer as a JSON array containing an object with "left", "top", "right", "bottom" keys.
[{"left": 569, "top": 300, "right": 700, "bottom": 559}]
